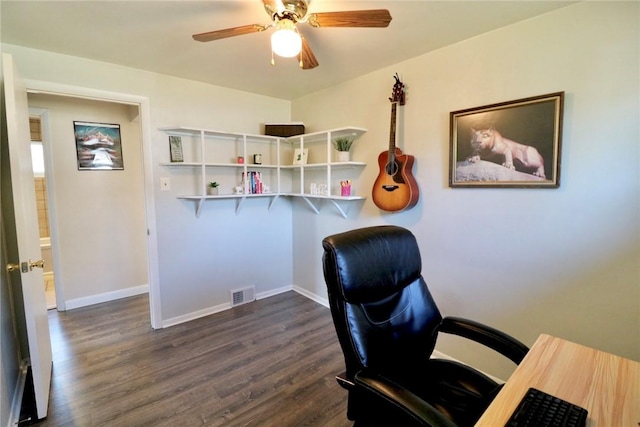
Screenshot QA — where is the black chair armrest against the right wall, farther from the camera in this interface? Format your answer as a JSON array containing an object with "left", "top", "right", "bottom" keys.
[{"left": 439, "top": 317, "right": 529, "bottom": 364}]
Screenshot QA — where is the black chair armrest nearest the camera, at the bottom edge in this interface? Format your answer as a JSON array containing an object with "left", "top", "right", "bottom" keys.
[{"left": 355, "top": 371, "right": 456, "bottom": 427}]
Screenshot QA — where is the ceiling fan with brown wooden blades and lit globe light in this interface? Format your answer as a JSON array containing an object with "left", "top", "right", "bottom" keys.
[{"left": 193, "top": 0, "right": 391, "bottom": 70}]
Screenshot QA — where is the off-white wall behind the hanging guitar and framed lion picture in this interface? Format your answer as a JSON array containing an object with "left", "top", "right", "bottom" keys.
[{"left": 292, "top": 2, "right": 640, "bottom": 378}]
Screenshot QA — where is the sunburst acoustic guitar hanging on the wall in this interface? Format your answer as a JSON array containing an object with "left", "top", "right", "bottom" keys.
[{"left": 371, "top": 74, "right": 419, "bottom": 212}]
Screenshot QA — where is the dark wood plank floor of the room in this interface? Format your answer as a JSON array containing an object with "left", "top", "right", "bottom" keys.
[{"left": 38, "top": 292, "right": 351, "bottom": 427}]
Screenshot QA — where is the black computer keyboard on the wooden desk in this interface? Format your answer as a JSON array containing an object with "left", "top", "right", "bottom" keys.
[{"left": 505, "top": 388, "right": 587, "bottom": 427}]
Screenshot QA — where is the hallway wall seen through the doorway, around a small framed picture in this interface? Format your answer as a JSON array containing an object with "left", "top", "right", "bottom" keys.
[{"left": 29, "top": 94, "right": 148, "bottom": 308}]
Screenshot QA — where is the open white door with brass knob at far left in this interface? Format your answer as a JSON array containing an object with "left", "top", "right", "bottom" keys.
[{"left": 2, "top": 53, "right": 52, "bottom": 418}]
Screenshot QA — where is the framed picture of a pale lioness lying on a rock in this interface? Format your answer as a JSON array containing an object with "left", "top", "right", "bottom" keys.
[{"left": 449, "top": 92, "right": 564, "bottom": 188}]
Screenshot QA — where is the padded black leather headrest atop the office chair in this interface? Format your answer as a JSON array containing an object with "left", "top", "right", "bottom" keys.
[{"left": 322, "top": 225, "right": 422, "bottom": 304}]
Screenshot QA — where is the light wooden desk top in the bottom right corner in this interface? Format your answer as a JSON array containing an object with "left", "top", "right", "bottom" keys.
[{"left": 476, "top": 335, "right": 640, "bottom": 427}]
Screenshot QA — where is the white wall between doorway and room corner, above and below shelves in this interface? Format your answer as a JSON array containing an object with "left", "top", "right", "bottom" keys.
[{"left": 2, "top": 44, "right": 293, "bottom": 321}]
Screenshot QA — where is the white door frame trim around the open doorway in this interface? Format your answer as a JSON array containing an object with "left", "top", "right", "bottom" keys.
[{"left": 24, "top": 79, "right": 162, "bottom": 329}]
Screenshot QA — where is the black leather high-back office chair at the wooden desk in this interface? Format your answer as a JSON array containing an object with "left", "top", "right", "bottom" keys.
[{"left": 322, "top": 226, "right": 529, "bottom": 427}]
